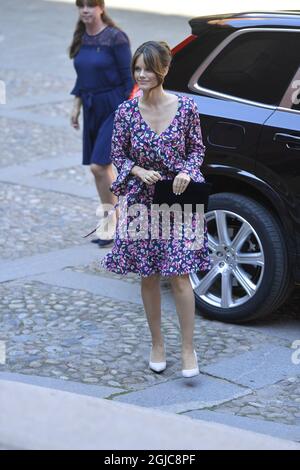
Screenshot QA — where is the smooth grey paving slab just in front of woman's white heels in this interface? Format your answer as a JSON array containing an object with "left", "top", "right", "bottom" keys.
[{"left": 116, "top": 374, "right": 251, "bottom": 413}]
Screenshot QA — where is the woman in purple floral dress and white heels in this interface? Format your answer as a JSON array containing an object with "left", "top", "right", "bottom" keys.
[{"left": 102, "top": 41, "right": 210, "bottom": 377}]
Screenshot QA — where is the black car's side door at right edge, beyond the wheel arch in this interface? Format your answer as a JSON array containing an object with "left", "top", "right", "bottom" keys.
[{"left": 256, "top": 63, "right": 300, "bottom": 253}]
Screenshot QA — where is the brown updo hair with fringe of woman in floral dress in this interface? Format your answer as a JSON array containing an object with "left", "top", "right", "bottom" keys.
[{"left": 131, "top": 41, "right": 172, "bottom": 86}]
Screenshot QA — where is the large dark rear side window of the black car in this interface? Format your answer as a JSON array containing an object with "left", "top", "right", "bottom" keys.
[{"left": 198, "top": 31, "right": 300, "bottom": 106}]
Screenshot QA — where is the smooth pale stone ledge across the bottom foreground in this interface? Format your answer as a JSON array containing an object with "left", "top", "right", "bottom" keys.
[{"left": 0, "top": 381, "right": 300, "bottom": 450}]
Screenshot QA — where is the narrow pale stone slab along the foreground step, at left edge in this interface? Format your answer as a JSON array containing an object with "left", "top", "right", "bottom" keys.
[{"left": 0, "top": 372, "right": 125, "bottom": 398}]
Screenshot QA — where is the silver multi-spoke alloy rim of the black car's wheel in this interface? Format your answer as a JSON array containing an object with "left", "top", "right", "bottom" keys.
[{"left": 190, "top": 210, "right": 265, "bottom": 309}]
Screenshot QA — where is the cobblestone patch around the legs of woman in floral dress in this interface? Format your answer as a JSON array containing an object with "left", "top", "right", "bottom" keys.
[{"left": 0, "top": 281, "right": 286, "bottom": 388}]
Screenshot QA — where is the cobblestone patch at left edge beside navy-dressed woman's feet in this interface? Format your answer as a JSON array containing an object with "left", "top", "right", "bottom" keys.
[{"left": 0, "top": 183, "right": 97, "bottom": 260}]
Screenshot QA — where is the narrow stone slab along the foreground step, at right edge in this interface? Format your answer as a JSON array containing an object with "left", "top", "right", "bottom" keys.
[{"left": 184, "top": 410, "right": 300, "bottom": 442}]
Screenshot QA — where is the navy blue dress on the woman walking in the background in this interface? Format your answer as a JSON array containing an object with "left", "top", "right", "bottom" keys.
[{"left": 71, "top": 26, "right": 133, "bottom": 165}]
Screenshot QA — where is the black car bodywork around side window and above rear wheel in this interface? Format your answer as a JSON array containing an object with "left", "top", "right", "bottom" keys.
[{"left": 166, "top": 11, "right": 300, "bottom": 283}]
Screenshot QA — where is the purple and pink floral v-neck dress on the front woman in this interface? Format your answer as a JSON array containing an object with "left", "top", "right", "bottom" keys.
[{"left": 101, "top": 96, "right": 210, "bottom": 277}]
